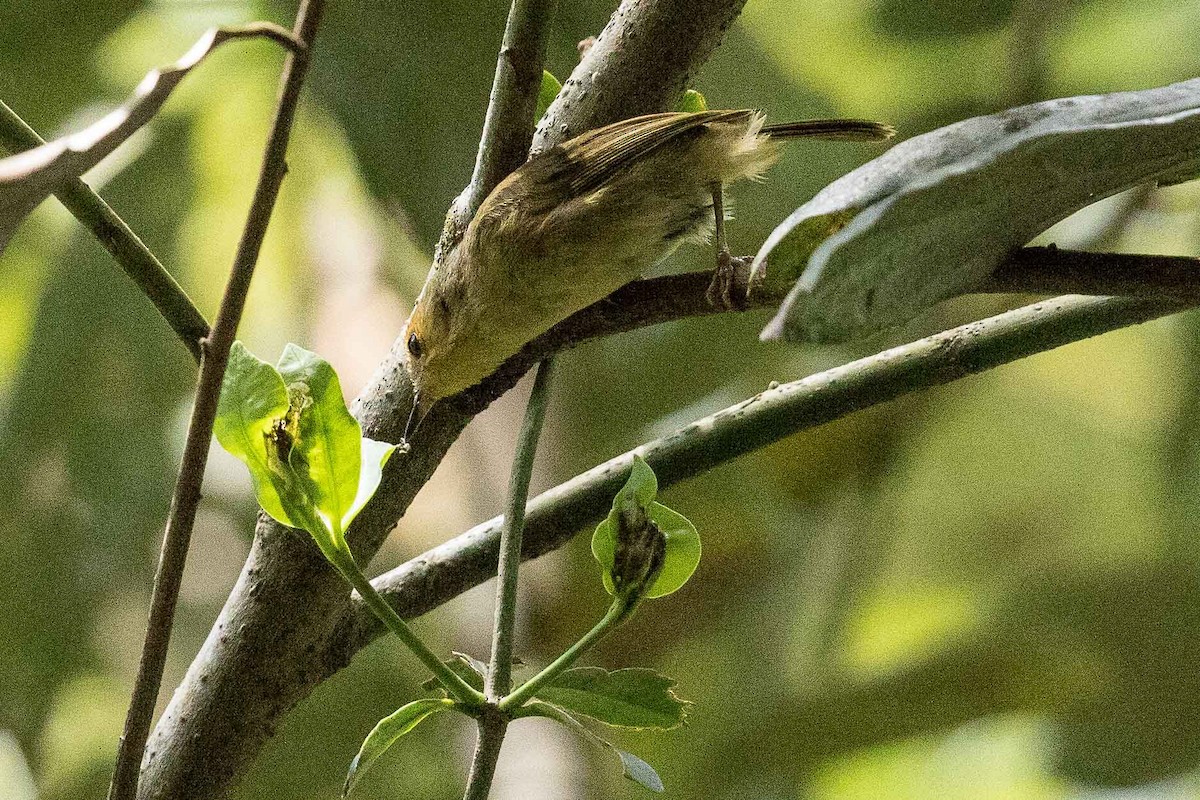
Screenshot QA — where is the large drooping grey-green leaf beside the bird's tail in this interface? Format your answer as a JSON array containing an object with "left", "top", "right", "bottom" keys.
[{"left": 755, "top": 79, "right": 1200, "bottom": 342}]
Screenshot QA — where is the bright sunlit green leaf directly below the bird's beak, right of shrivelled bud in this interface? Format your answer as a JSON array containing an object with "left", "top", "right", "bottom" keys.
[{"left": 278, "top": 344, "right": 360, "bottom": 537}]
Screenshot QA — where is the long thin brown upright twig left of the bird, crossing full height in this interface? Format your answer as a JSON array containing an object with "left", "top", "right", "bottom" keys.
[{"left": 108, "top": 6, "right": 324, "bottom": 800}]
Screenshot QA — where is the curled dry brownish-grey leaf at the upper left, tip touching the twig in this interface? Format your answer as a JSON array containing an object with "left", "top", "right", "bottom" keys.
[{"left": 0, "top": 23, "right": 294, "bottom": 251}]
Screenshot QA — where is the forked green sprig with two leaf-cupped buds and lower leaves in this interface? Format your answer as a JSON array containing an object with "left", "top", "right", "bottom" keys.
[{"left": 214, "top": 342, "right": 700, "bottom": 793}]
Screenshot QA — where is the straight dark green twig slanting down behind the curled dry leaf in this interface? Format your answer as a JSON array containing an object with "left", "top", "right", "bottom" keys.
[{"left": 0, "top": 102, "right": 209, "bottom": 361}]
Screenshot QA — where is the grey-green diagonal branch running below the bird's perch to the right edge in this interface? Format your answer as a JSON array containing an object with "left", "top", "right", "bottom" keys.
[{"left": 355, "top": 291, "right": 1189, "bottom": 642}]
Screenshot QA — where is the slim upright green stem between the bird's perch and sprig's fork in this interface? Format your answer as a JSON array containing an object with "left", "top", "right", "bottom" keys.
[{"left": 487, "top": 359, "right": 553, "bottom": 703}]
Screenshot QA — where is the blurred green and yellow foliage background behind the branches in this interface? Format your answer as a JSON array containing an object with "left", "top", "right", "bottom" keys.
[{"left": 0, "top": 0, "right": 1200, "bottom": 800}]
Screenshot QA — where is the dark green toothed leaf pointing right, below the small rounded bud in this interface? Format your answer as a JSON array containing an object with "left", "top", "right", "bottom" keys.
[{"left": 538, "top": 667, "right": 691, "bottom": 730}]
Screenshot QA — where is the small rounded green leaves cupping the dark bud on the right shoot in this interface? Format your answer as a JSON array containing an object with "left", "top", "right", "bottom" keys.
[{"left": 592, "top": 455, "right": 701, "bottom": 597}]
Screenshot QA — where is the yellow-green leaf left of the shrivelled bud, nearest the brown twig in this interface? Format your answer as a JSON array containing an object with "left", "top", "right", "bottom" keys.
[{"left": 212, "top": 342, "right": 296, "bottom": 527}]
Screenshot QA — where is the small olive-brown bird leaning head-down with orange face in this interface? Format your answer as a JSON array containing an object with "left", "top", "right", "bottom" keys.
[{"left": 403, "top": 110, "right": 894, "bottom": 429}]
